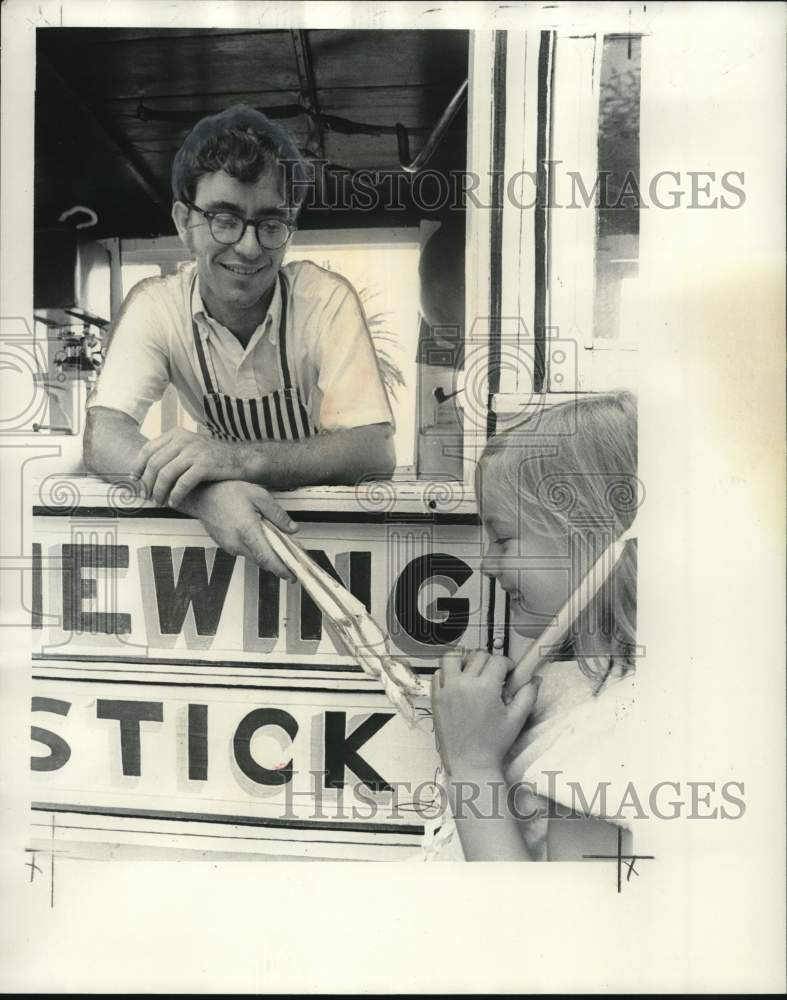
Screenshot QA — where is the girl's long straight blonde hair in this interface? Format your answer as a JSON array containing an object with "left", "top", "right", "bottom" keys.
[{"left": 479, "top": 391, "right": 644, "bottom": 674}]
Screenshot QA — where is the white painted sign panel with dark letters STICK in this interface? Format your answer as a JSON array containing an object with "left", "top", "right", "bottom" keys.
[{"left": 31, "top": 680, "right": 444, "bottom": 857}]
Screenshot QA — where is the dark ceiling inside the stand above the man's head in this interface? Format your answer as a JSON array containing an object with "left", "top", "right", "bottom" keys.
[{"left": 35, "top": 28, "right": 468, "bottom": 237}]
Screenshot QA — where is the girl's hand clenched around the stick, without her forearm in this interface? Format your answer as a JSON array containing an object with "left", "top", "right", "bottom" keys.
[{"left": 432, "top": 650, "right": 539, "bottom": 774}]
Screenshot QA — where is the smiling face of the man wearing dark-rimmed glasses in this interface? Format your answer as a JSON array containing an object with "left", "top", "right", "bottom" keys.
[{"left": 175, "top": 171, "right": 291, "bottom": 319}]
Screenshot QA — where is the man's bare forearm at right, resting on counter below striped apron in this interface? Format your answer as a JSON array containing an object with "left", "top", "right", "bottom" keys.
[{"left": 238, "top": 424, "right": 395, "bottom": 490}]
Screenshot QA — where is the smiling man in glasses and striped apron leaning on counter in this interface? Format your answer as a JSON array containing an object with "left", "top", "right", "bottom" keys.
[{"left": 84, "top": 105, "right": 394, "bottom": 576}]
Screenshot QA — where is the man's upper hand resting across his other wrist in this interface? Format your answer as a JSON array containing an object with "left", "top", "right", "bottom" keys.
[{"left": 134, "top": 427, "right": 248, "bottom": 508}]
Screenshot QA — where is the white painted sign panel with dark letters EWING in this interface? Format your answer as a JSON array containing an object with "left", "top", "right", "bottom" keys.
[{"left": 33, "top": 517, "right": 490, "bottom": 662}]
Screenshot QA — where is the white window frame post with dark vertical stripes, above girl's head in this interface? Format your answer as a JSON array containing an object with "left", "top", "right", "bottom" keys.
[{"left": 492, "top": 25, "right": 647, "bottom": 406}]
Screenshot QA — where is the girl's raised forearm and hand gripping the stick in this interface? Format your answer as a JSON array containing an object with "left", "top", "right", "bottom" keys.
[{"left": 432, "top": 650, "right": 539, "bottom": 861}]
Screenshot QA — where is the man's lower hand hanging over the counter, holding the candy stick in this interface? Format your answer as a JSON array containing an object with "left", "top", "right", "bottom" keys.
[{"left": 181, "top": 481, "right": 298, "bottom": 583}]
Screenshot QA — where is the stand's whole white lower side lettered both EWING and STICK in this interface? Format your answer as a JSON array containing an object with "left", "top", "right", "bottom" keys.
[{"left": 31, "top": 512, "right": 486, "bottom": 859}]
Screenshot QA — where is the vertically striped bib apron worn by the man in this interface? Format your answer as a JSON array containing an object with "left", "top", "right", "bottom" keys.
[{"left": 191, "top": 271, "right": 317, "bottom": 441}]
